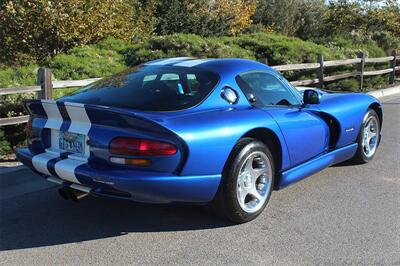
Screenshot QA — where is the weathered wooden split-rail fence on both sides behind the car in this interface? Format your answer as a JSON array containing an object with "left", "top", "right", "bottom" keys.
[{"left": 0, "top": 51, "right": 400, "bottom": 127}]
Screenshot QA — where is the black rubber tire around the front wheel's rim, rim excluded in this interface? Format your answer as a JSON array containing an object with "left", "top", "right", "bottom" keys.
[{"left": 351, "top": 109, "right": 381, "bottom": 164}]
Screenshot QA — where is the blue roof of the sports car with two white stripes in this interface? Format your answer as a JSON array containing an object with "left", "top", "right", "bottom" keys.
[{"left": 145, "top": 57, "right": 276, "bottom": 75}]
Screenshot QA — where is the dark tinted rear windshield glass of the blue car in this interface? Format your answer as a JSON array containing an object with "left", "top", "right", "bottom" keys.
[{"left": 60, "top": 66, "right": 219, "bottom": 111}]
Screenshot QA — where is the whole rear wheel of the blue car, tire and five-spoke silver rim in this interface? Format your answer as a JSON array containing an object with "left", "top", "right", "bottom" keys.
[{"left": 214, "top": 138, "right": 275, "bottom": 223}]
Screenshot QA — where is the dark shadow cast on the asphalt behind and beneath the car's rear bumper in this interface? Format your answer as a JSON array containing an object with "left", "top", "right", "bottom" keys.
[{"left": 0, "top": 169, "right": 232, "bottom": 250}]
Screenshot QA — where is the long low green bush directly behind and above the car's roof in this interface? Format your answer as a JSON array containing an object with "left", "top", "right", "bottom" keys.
[{"left": 125, "top": 33, "right": 344, "bottom": 65}]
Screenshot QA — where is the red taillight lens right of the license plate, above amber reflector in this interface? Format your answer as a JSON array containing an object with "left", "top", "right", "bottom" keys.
[{"left": 110, "top": 137, "right": 177, "bottom": 156}]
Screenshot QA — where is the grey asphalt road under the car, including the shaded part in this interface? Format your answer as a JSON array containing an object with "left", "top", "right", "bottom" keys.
[{"left": 0, "top": 96, "right": 400, "bottom": 265}]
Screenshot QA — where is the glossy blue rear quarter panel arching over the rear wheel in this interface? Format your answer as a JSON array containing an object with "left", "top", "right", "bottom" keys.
[{"left": 156, "top": 107, "right": 290, "bottom": 175}]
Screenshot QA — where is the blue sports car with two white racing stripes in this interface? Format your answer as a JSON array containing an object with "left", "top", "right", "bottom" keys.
[{"left": 17, "top": 58, "right": 382, "bottom": 223}]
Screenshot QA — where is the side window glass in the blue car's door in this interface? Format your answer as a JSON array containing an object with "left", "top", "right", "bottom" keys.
[{"left": 236, "top": 72, "right": 299, "bottom": 105}]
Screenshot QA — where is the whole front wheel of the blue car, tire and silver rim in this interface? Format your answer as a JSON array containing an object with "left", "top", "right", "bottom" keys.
[{"left": 353, "top": 109, "right": 381, "bottom": 163}]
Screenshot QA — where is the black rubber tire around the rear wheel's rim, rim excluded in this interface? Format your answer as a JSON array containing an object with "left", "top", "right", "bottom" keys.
[{"left": 212, "top": 138, "right": 275, "bottom": 223}]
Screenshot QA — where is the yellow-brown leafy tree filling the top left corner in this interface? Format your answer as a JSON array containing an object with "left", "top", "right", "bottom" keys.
[{"left": 0, "top": 0, "right": 133, "bottom": 65}]
